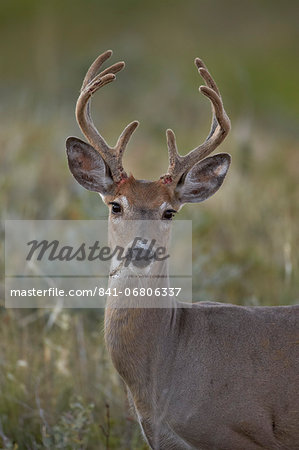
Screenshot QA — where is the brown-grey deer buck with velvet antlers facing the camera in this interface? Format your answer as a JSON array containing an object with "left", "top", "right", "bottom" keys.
[{"left": 66, "top": 51, "right": 299, "bottom": 450}]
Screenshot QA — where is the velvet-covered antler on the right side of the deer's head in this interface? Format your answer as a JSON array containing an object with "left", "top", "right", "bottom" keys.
[{"left": 160, "top": 58, "right": 230, "bottom": 184}]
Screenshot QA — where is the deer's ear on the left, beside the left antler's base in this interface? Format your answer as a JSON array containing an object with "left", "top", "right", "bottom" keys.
[{"left": 66, "top": 137, "right": 115, "bottom": 195}]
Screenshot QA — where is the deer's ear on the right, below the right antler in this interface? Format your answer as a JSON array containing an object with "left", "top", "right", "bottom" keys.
[{"left": 176, "top": 153, "right": 231, "bottom": 203}]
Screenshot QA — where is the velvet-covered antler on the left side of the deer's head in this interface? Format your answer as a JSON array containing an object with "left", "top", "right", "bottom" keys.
[{"left": 76, "top": 50, "right": 139, "bottom": 182}]
